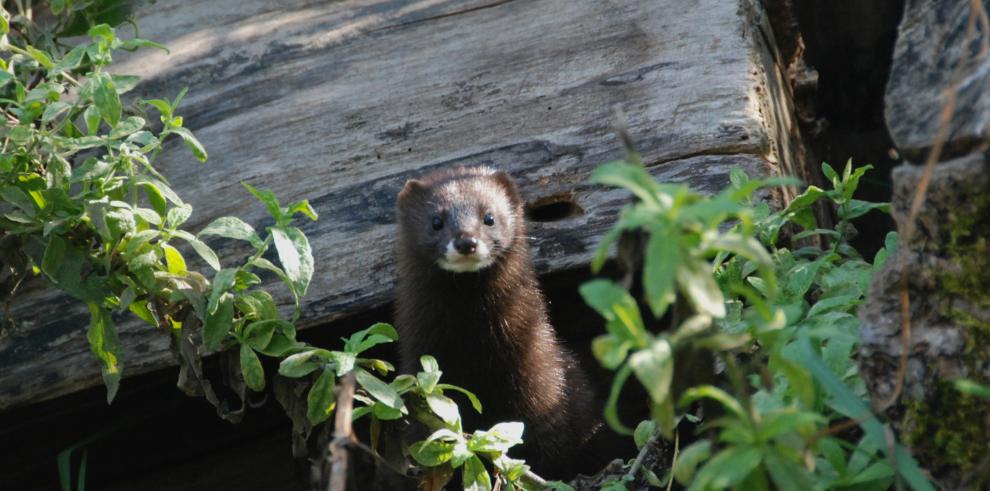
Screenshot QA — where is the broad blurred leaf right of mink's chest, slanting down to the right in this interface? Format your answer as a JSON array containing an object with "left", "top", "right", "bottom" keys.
[{"left": 580, "top": 280, "right": 648, "bottom": 348}]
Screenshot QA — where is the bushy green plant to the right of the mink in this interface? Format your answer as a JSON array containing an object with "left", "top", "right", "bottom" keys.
[{"left": 581, "top": 155, "right": 932, "bottom": 490}]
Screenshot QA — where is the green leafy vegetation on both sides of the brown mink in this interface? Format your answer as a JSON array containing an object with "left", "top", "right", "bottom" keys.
[{"left": 0, "top": 0, "right": 944, "bottom": 490}]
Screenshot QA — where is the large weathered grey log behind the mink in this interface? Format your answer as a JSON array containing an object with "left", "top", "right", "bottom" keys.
[{"left": 0, "top": 0, "right": 796, "bottom": 409}]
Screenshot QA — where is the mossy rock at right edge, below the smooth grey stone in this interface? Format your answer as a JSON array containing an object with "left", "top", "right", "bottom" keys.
[{"left": 859, "top": 154, "right": 990, "bottom": 489}]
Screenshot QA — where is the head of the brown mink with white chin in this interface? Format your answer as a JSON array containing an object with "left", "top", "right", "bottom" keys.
[{"left": 398, "top": 167, "right": 524, "bottom": 273}]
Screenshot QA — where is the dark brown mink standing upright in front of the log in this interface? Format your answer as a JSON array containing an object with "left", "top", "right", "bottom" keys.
[{"left": 396, "top": 167, "right": 601, "bottom": 477}]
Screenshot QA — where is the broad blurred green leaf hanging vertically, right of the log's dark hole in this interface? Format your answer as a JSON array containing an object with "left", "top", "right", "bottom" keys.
[{"left": 643, "top": 227, "right": 681, "bottom": 319}]
